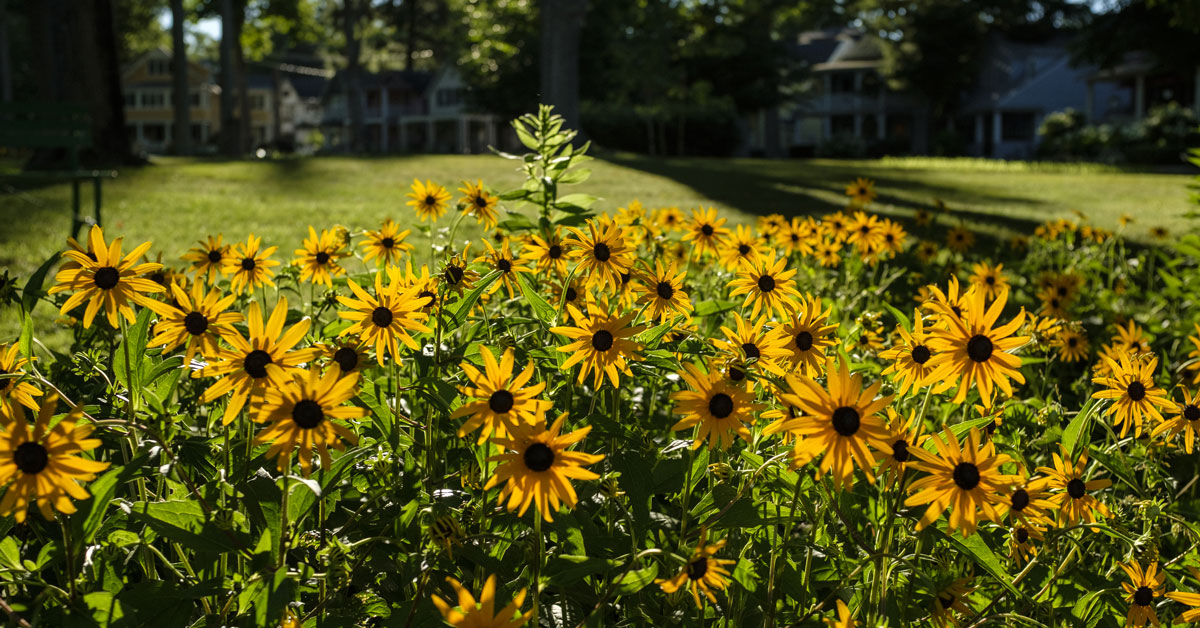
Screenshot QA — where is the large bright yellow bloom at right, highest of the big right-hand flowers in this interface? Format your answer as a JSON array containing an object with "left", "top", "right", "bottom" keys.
[{"left": 928, "top": 292, "right": 1030, "bottom": 406}]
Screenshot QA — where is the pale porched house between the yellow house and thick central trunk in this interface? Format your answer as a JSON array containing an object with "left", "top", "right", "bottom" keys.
[{"left": 320, "top": 67, "right": 498, "bottom": 154}]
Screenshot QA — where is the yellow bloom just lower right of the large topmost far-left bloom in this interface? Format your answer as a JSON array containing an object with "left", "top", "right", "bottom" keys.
[{"left": 146, "top": 281, "right": 242, "bottom": 365}]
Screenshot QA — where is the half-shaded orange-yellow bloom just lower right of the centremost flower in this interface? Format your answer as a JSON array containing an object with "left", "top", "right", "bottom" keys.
[{"left": 671, "top": 364, "right": 764, "bottom": 449}]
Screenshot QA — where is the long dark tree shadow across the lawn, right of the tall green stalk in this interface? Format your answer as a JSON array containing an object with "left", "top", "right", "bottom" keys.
[{"left": 602, "top": 155, "right": 1046, "bottom": 239}]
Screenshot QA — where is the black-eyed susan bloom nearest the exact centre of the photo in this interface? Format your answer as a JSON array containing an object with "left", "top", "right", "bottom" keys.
[{"left": 550, "top": 305, "right": 646, "bottom": 388}]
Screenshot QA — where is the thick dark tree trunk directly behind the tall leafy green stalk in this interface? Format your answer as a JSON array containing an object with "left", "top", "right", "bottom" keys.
[{"left": 540, "top": 0, "right": 588, "bottom": 135}]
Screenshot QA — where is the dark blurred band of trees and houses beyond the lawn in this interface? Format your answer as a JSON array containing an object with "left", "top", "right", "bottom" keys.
[{"left": 7, "top": 0, "right": 1200, "bottom": 166}]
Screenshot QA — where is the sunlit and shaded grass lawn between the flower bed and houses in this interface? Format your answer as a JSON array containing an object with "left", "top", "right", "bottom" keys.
[{"left": 0, "top": 155, "right": 1192, "bottom": 340}]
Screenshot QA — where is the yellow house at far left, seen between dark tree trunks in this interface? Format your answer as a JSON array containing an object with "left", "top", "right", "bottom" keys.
[{"left": 121, "top": 48, "right": 275, "bottom": 152}]
